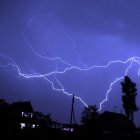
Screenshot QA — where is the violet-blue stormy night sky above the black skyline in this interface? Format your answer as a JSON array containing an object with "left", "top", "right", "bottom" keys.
[{"left": 0, "top": 0, "right": 140, "bottom": 125}]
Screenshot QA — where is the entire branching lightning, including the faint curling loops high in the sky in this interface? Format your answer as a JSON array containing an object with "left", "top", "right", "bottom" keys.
[{"left": 0, "top": 15, "right": 140, "bottom": 111}]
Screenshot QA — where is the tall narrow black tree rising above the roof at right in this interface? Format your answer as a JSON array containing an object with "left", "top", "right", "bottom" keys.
[{"left": 121, "top": 76, "right": 138, "bottom": 120}]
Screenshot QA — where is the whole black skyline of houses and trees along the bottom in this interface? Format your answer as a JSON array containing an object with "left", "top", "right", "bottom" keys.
[{"left": 0, "top": 76, "right": 140, "bottom": 139}]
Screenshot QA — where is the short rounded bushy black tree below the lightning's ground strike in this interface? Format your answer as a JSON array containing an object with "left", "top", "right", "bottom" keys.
[{"left": 81, "top": 105, "right": 99, "bottom": 129}]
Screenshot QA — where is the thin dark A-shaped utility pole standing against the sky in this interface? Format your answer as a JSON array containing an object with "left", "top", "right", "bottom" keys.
[{"left": 70, "top": 94, "right": 75, "bottom": 131}]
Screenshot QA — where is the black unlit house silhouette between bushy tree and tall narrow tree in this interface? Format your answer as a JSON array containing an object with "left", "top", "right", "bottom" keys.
[{"left": 98, "top": 111, "right": 136, "bottom": 135}]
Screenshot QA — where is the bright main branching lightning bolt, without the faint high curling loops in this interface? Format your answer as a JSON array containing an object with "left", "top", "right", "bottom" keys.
[{"left": 0, "top": 46, "right": 140, "bottom": 111}]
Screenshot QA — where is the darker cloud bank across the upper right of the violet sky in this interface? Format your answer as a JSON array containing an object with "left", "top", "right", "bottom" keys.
[{"left": 55, "top": 0, "right": 140, "bottom": 41}]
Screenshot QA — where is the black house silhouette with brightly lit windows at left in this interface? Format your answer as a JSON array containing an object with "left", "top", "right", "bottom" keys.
[{"left": 9, "top": 101, "right": 35, "bottom": 129}]
